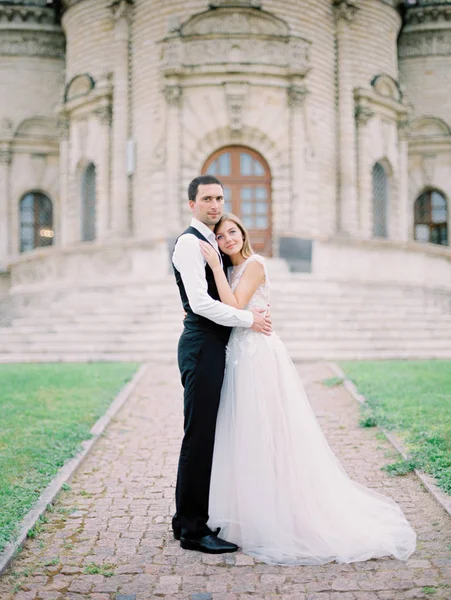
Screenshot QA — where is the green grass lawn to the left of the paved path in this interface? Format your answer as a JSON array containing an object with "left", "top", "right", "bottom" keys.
[{"left": 0, "top": 363, "right": 138, "bottom": 551}]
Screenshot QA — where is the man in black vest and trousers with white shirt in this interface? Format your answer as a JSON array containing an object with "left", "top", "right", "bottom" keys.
[{"left": 172, "top": 175, "right": 271, "bottom": 554}]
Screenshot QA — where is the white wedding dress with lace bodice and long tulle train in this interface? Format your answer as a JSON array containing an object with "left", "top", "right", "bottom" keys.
[{"left": 208, "top": 254, "right": 416, "bottom": 565}]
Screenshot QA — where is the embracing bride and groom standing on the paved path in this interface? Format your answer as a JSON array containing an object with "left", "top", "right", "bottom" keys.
[{"left": 172, "top": 175, "right": 416, "bottom": 565}]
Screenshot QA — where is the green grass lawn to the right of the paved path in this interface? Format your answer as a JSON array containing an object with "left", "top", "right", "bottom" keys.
[{"left": 340, "top": 360, "right": 451, "bottom": 494}]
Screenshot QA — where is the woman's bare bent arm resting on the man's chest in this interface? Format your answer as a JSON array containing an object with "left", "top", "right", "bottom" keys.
[{"left": 200, "top": 241, "right": 265, "bottom": 308}]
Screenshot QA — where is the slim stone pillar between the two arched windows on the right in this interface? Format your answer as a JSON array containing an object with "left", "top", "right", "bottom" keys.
[{"left": 396, "top": 121, "right": 414, "bottom": 242}]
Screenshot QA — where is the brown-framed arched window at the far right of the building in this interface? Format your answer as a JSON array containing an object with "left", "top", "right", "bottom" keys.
[{"left": 414, "top": 190, "right": 448, "bottom": 246}]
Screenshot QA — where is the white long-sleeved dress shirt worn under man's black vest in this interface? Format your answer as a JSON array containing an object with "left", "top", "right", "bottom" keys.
[{"left": 172, "top": 219, "right": 254, "bottom": 327}]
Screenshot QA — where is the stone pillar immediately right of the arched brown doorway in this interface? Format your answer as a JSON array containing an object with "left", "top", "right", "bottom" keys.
[{"left": 288, "top": 85, "right": 311, "bottom": 235}]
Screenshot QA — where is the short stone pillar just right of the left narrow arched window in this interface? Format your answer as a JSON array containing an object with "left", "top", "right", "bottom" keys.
[{"left": 94, "top": 104, "right": 112, "bottom": 240}]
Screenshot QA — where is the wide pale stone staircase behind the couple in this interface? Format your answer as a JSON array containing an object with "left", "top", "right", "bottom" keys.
[{"left": 0, "top": 261, "right": 451, "bottom": 362}]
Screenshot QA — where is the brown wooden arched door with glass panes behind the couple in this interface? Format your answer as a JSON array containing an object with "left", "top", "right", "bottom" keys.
[{"left": 202, "top": 146, "right": 271, "bottom": 255}]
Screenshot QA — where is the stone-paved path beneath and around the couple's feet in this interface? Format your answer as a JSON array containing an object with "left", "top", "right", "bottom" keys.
[{"left": 0, "top": 364, "right": 451, "bottom": 600}]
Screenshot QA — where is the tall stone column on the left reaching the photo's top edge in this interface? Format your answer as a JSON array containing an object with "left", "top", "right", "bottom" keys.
[{"left": 110, "top": 0, "right": 131, "bottom": 237}]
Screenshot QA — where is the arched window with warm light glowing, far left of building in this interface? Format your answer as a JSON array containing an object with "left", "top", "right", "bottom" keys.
[{"left": 19, "top": 192, "right": 54, "bottom": 252}]
